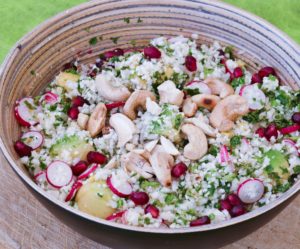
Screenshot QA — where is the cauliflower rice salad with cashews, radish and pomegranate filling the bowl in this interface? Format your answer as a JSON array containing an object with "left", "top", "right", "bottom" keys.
[{"left": 14, "top": 35, "right": 300, "bottom": 228}]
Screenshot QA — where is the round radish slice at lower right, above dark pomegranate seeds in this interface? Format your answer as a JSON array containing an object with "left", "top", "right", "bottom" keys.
[{"left": 237, "top": 179, "right": 265, "bottom": 204}]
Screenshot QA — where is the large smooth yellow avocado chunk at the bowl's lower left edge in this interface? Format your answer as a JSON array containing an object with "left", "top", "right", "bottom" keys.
[{"left": 75, "top": 181, "right": 116, "bottom": 219}]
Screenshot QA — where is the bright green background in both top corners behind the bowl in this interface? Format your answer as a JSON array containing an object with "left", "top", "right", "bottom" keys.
[{"left": 0, "top": 0, "right": 300, "bottom": 62}]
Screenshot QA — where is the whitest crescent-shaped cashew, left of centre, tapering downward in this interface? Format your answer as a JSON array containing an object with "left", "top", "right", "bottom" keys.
[{"left": 109, "top": 113, "right": 136, "bottom": 147}]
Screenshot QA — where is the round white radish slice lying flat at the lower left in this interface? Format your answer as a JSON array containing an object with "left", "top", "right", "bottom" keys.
[{"left": 46, "top": 160, "right": 73, "bottom": 188}]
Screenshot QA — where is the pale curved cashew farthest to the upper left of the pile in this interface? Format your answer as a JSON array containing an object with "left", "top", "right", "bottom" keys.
[{"left": 95, "top": 72, "right": 130, "bottom": 101}]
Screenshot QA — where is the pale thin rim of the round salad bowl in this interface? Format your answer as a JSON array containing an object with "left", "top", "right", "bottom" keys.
[{"left": 0, "top": 0, "right": 300, "bottom": 234}]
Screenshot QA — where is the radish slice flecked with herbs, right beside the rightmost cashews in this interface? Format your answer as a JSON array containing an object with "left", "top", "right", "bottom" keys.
[{"left": 239, "top": 84, "right": 266, "bottom": 110}]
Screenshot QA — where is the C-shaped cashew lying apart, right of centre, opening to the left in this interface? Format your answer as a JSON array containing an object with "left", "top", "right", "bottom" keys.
[{"left": 181, "top": 124, "right": 207, "bottom": 160}]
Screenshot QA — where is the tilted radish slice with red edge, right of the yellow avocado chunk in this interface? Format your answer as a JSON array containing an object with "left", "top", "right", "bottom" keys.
[{"left": 106, "top": 175, "right": 132, "bottom": 198}]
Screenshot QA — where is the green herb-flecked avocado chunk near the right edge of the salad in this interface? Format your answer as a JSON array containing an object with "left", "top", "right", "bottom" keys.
[{"left": 264, "top": 150, "right": 290, "bottom": 183}]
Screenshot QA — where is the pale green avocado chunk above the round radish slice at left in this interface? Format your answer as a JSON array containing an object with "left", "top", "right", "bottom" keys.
[{"left": 49, "top": 135, "right": 94, "bottom": 162}]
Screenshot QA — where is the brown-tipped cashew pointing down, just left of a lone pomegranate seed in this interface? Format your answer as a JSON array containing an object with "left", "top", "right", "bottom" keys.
[{"left": 149, "top": 145, "right": 174, "bottom": 187}]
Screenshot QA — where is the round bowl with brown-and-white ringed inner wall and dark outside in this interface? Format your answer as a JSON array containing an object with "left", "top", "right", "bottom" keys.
[{"left": 0, "top": 0, "right": 300, "bottom": 248}]
